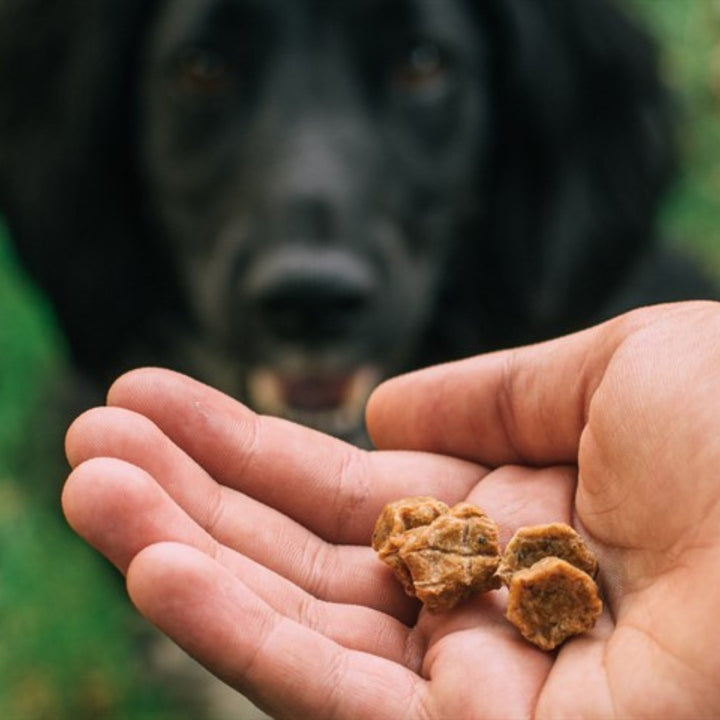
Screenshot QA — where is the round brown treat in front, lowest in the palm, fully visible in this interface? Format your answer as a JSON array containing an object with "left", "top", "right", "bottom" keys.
[{"left": 506, "top": 557, "right": 602, "bottom": 650}]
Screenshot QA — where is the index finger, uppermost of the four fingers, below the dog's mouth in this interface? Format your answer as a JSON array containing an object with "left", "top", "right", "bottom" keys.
[{"left": 98, "top": 369, "right": 484, "bottom": 545}]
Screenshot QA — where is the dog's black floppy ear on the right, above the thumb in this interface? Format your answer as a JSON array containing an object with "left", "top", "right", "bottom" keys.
[{"left": 476, "top": 0, "right": 676, "bottom": 335}]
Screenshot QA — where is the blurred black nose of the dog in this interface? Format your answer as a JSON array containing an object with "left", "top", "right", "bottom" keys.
[{"left": 243, "top": 249, "right": 374, "bottom": 344}]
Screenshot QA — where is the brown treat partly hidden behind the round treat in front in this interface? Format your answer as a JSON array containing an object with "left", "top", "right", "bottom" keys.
[{"left": 498, "top": 523, "right": 598, "bottom": 585}]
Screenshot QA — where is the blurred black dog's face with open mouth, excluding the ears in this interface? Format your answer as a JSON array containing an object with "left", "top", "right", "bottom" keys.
[{"left": 138, "top": 0, "right": 490, "bottom": 435}]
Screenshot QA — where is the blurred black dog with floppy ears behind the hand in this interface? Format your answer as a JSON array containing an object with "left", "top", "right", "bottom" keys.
[{"left": 0, "top": 0, "right": 712, "bottom": 441}]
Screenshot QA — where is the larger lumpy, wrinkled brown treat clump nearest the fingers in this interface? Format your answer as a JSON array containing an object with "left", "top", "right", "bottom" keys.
[{"left": 372, "top": 497, "right": 500, "bottom": 612}]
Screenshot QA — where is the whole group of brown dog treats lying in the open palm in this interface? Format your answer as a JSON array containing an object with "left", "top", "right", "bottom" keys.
[{"left": 372, "top": 496, "right": 602, "bottom": 650}]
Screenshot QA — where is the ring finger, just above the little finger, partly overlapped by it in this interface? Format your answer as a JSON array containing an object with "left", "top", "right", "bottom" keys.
[{"left": 63, "top": 458, "right": 419, "bottom": 664}]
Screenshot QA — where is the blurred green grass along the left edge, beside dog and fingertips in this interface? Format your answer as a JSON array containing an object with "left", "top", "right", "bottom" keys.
[{"left": 0, "top": 227, "right": 183, "bottom": 720}]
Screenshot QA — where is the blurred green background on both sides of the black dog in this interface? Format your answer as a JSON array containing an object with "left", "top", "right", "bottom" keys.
[{"left": 0, "top": 0, "right": 720, "bottom": 720}]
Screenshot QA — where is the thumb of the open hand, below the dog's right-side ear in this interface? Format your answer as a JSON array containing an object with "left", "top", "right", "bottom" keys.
[{"left": 367, "top": 306, "right": 683, "bottom": 466}]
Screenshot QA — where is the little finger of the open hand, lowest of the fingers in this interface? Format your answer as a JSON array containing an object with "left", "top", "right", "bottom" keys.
[{"left": 128, "top": 544, "right": 425, "bottom": 720}]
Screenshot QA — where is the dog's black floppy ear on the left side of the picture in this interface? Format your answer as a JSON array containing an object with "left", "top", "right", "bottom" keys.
[{"left": 0, "top": 0, "right": 180, "bottom": 382}]
